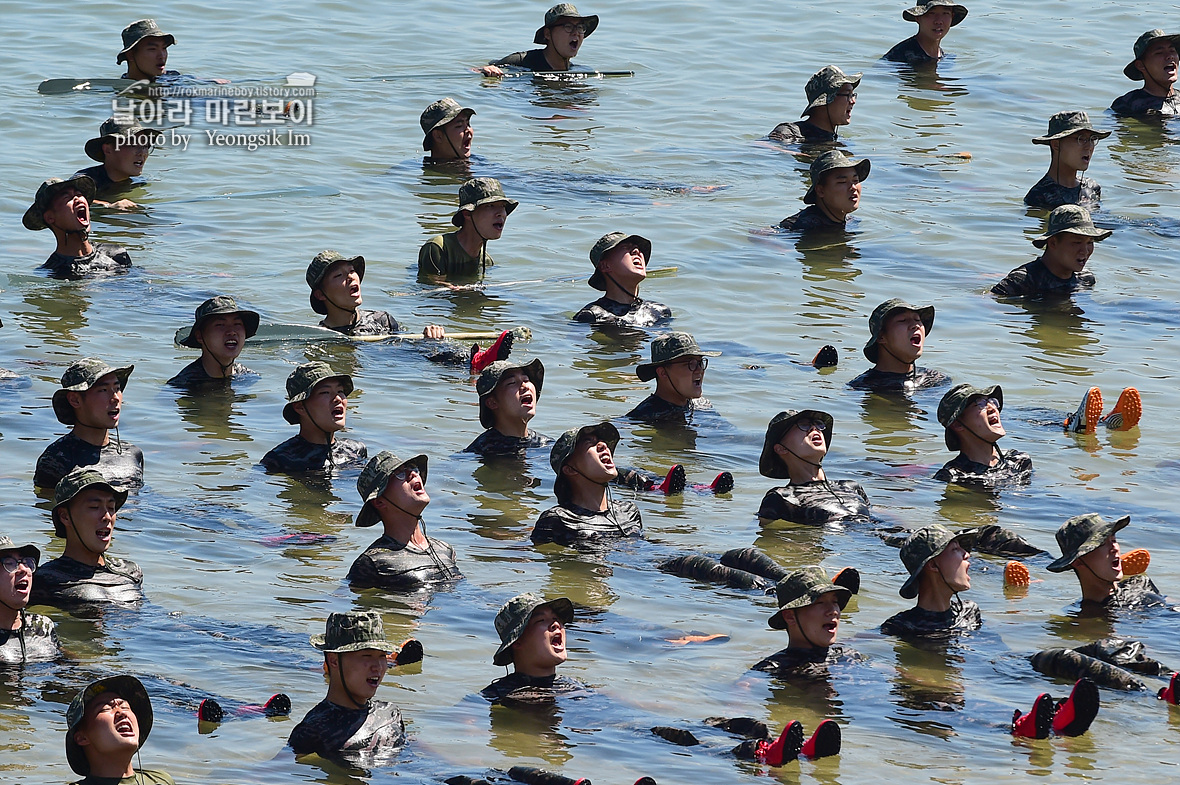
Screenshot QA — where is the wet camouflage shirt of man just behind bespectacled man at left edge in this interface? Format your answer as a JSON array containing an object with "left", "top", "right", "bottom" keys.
[{"left": 31, "top": 554, "right": 144, "bottom": 608}]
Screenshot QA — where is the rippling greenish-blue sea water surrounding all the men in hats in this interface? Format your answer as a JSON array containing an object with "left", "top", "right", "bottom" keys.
[{"left": 0, "top": 0, "right": 1180, "bottom": 785}]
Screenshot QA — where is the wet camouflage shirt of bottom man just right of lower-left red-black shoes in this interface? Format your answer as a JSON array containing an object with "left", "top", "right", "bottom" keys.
[{"left": 287, "top": 694, "right": 406, "bottom": 768}]
